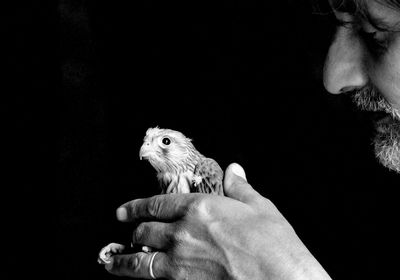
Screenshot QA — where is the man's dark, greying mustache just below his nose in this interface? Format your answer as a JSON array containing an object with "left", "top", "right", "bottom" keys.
[{"left": 350, "top": 84, "right": 400, "bottom": 121}]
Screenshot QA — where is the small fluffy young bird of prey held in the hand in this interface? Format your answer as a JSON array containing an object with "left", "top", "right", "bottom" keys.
[{"left": 98, "top": 127, "right": 224, "bottom": 264}]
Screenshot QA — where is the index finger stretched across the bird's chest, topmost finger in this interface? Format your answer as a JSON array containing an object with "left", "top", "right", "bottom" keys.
[{"left": 117, "top": 193, "right": 201, "bottom": 222}]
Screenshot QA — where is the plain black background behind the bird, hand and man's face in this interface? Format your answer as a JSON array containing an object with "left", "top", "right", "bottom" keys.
[{"left": 2, "top": 0, "right": 399, "bottom": 279}]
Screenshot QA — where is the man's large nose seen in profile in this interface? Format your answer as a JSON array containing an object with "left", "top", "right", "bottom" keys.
[{"left": 323, "top": 27, "right": 368, "bottom": 94}]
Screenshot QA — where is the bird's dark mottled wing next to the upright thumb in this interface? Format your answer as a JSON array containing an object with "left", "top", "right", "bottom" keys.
[{"left": 190, "top": 158, "right": 224, "bottom": 195}]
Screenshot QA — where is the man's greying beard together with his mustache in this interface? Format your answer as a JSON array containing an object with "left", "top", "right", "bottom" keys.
[{"left": 352, "top": 85, "right": 400, "bottom": 173}]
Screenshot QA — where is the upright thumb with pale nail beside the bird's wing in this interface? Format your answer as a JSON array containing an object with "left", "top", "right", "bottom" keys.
[{"left": 224, "top": 163, "right": 259, "bottom": 204}]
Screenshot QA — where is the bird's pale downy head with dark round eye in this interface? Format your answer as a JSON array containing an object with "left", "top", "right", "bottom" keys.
[{"left": 139, "top": 127, "right": 198, "bottom": 173}]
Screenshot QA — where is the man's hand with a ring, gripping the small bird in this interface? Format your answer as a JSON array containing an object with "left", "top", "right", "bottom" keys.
[{"left": 105, "top": 163, "right": 331, "bottom": 280}]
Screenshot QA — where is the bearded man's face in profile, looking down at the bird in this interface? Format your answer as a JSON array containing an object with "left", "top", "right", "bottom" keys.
[{"left": 324, "top": 0, "right": 400, "bottom": 172}]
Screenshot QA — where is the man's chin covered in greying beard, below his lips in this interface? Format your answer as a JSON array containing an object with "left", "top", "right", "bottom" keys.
[{"left": 374, "top": 115, "right": 400, "bottom": 173}]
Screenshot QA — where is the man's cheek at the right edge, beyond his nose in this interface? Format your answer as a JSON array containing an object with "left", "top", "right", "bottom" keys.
[{"left": 369, "top": 43, "right": 400, "bottom": 109}]
